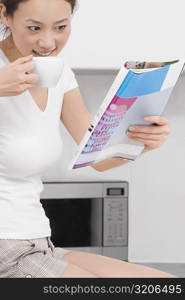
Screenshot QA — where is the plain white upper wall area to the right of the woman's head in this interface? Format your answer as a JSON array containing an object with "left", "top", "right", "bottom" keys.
[{"left": 62, "top": 0, "right": 185, "bottom": 68}]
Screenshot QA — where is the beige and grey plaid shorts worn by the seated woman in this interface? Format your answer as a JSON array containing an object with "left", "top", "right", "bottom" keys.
[{"left": 0, "top": 237, "right": 72, "bottom": 278}]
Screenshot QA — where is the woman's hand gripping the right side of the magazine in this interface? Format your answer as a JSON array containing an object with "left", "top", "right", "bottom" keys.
[{"left": 127, "top": 116, "right": 170, "bottom": 152}]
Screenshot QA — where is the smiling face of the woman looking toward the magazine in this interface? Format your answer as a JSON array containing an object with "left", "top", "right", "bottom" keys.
[{"left": 2, "top": 0, "right": 72, "bottom": 56}]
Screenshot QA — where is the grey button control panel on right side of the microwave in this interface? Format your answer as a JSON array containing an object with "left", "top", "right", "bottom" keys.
[{"left": 103, "top": 195, "right": 128, "bottom": 246}]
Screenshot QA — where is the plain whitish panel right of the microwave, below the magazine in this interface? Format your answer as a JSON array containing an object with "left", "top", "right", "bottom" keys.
[{"left": 129, "top": 74, "right": 185, "bottom": 262}]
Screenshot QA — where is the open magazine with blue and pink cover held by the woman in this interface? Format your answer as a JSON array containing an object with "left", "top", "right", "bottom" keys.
[{"left": 69, "top": 60, "right": 185, "bottom": 169}]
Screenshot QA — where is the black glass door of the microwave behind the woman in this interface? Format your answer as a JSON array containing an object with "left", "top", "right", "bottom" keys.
[{"left": 41, "top": 198, "right": 103, "bottom": 248}]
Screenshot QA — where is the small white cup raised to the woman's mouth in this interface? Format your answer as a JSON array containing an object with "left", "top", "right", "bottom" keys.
[{"left": 32, "top": 56, "right": 64, "bottom": 88}]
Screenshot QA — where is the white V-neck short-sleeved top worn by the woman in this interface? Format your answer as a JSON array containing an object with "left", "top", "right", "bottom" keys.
[{"left": 0, "top": 49, "right": 78, "bottom": 239}]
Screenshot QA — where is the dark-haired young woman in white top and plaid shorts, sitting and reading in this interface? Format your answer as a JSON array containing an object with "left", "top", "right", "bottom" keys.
[{"left": 0, "top": 0, "right": 173, "bottom": 278}]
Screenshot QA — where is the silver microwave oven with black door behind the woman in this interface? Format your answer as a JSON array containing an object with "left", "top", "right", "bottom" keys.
[{"left": 41, "top": 181, "right": 129, "bottom": 261}]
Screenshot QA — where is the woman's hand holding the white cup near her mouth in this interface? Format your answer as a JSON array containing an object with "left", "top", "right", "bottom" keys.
[{"left": 0, "top": 55, "right": 38, "bottom": 97}]
